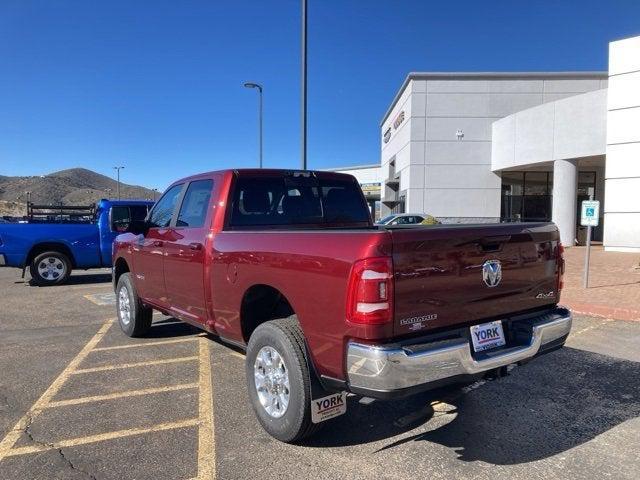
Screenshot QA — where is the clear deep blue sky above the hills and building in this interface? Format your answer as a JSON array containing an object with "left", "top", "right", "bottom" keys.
[{"left": 0, "top": 0, "right": 640, "bottom": 189}]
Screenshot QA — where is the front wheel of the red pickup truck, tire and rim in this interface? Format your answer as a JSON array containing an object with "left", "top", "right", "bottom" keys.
[{"left": 116, "top": 273, "right": 153, "bottom": 337}]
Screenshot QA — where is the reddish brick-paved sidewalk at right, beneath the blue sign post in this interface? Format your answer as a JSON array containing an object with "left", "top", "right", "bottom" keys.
[{"left": 560, "top": 246, "right": 640, "bottom": 320}]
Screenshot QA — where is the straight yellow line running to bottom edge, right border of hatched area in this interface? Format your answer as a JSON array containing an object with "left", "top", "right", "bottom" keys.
[{"left": 198, "top": 338, "right": 216, "bottom": 480}]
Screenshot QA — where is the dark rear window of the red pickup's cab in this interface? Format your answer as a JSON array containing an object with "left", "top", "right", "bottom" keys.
[{"left": 229, "top": 174, "right": 370, "bottom": 227}]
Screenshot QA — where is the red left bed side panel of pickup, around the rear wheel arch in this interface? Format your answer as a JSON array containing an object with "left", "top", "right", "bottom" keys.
[{"left": 210, "top": 229, "right": 392, "bottom": 378}]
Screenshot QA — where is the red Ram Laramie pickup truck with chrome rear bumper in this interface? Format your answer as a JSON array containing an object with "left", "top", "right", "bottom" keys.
[{"left": 113, "top": 170, "right": 571, "bottom": 442}]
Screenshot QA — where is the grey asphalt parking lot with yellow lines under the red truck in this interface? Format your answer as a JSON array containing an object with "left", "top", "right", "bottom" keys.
[{"left": 0, "top": 269, "right": 640, "bottom": 480}]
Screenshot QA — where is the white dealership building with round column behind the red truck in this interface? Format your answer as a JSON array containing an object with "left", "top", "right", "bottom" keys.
[{"left": 340, "top": 37, "right": 640, "bottom": 251}]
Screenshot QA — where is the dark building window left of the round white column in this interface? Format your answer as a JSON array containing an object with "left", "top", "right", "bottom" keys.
[{"left": 500, "top": 172, "right": 553, "bottom": 222}]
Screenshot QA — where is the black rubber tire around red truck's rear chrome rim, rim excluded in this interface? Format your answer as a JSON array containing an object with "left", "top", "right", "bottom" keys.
[{"left": 245, "top": 315, "right": 322, "bottom": 443}]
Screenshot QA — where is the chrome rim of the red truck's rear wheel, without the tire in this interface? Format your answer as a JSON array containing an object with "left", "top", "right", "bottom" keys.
[{"left": 253, "top": 346, "right": 290, "bottom": 418}]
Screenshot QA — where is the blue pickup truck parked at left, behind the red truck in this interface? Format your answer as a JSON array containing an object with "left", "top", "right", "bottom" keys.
[{"left": 0, "top": 200, "right": 153, "bottom": 286}]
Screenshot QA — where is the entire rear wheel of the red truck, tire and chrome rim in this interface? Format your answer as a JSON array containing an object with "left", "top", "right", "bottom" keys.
[{"left": 245, "top": 315, "right": 320, "bottom": 443}]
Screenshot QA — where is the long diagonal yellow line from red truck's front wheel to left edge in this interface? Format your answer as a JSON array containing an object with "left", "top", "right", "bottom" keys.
[{"left": 0, "top": 318, "right": 115, "bottom": 461}]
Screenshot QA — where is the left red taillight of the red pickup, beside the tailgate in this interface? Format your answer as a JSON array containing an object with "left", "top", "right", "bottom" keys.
[{"left": 347, "top": 257, "right": 393, "bottom": 325}]
